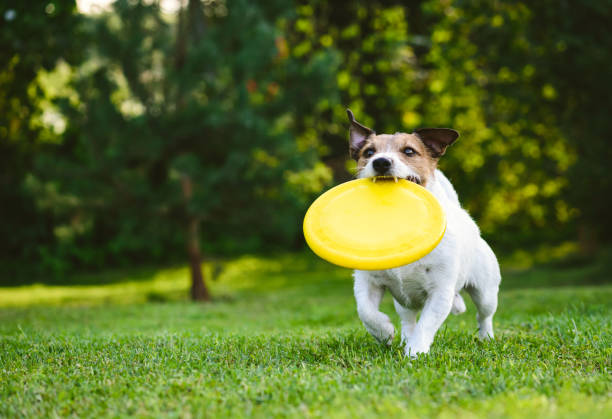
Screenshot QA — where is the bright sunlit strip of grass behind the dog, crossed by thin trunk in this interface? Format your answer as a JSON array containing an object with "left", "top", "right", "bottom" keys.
[{"left": 0, "top": 254, "right": 350, "bottom": 307}]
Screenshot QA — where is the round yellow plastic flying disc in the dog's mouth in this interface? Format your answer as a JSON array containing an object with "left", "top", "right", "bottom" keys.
[{"left": 304, "top": 179, "right": 446, "bottom": 270}]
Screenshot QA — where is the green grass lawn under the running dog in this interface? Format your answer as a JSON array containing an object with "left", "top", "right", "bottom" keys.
[{"left": 0, "top": 255, "right": 612, "bottom": 418}]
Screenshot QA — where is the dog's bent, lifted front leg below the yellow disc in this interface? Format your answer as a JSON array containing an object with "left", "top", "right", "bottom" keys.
[{"left": 354, "top": 271, "right": 395, "bottom": 345}]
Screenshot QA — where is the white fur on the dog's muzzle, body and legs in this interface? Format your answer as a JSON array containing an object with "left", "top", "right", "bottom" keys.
[{"left": 354, "top": 162, "right": 501, "bottom": 357}]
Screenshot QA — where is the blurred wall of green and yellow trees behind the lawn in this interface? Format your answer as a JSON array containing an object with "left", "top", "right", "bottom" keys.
[{"left": 0, "top": 0, "right": 612, "bottom": 298}]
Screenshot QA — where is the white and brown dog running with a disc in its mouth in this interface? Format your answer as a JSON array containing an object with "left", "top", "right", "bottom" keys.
[{"left": 347, "top": 109, "right": 501, "bottom": 358}]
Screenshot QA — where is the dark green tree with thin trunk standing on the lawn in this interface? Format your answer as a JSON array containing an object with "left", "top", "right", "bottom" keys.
[{"left": 32, "top": 0, "right": 335, "bottom": 300}]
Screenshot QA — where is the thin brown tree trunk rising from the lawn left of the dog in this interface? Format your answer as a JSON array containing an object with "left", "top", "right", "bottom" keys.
[{"left": 181, "top": 175, "right": 210, "bottom": 301}]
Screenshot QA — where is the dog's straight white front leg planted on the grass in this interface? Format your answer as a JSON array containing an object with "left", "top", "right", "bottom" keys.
[{"left": 405, "top": 288, "right": 455, "bottom": 358}]
